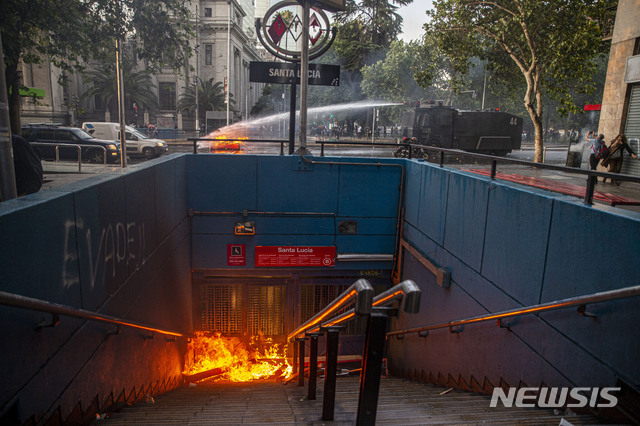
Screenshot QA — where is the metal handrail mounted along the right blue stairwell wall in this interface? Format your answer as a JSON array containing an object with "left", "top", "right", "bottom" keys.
[{"left": 387, "top": 285, "right": 640, "bottom": 336}]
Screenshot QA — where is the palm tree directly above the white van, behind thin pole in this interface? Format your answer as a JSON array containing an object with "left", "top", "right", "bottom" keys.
[{"left": 82, "top": 58, "right": 158, "bottom": 120}]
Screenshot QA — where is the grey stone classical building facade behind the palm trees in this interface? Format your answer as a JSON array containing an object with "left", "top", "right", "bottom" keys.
[{"left": 22, "top": 0, "right": 264, "bottom": 131}]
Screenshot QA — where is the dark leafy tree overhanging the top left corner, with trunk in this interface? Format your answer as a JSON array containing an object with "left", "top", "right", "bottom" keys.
[{"left": 0, "top": 0, "right": 192, "bottom": 131}]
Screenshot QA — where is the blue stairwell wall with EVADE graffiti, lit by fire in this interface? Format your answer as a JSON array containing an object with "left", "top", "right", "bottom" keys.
[{"left": 0, "top": 156, "right": 192, "bottom": 421}]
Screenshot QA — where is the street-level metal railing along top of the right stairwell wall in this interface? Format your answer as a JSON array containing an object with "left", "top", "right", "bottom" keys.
[{"left": 316, "top": 141, "right": 640, "bottom": 204}]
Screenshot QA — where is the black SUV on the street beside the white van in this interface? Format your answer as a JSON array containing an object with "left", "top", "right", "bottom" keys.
[{"left": 22, "top": 124, "right": 120, "bottom": 163}]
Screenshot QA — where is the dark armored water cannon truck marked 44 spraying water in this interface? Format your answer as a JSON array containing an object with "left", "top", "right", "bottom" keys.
[{"left": 394, "top": 104, "right": 522, "bottom": 157}]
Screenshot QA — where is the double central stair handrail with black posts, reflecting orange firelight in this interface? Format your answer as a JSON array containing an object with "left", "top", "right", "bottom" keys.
[{"left": 288, "top": 279, "right": 420, "bottom": 425}]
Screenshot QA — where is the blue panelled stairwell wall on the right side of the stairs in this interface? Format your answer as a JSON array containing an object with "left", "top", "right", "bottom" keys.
[{"left": 389, "top": 161, "right": 640, "bottom": 392}]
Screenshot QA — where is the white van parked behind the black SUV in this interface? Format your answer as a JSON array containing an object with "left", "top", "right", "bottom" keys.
[{"left": 82, "top": 122, "right": 169, "bottom": 158}]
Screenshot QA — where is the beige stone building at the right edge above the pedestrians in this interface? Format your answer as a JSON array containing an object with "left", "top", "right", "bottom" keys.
[{"left": 598, "top": 0, "right": 640, "bottom": 175}]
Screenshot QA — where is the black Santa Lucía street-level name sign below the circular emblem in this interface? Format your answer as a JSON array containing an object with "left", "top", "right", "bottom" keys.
[{"left": 249, "top": 62, "right": 340, "bottom": 86}]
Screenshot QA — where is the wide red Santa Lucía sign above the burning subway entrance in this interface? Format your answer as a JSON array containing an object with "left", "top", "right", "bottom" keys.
[{"left": 255, "top": 246, "right": 336, "bottom": 267}]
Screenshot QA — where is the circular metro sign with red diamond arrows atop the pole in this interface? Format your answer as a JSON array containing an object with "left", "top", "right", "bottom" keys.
[{"left": 256, "top": 0, "right": 336, "bottom": 62}]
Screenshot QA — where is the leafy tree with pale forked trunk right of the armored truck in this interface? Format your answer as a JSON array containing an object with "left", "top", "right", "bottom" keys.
[{"left": 425, "top": 0, "right": 607, "bottom": 162}]
